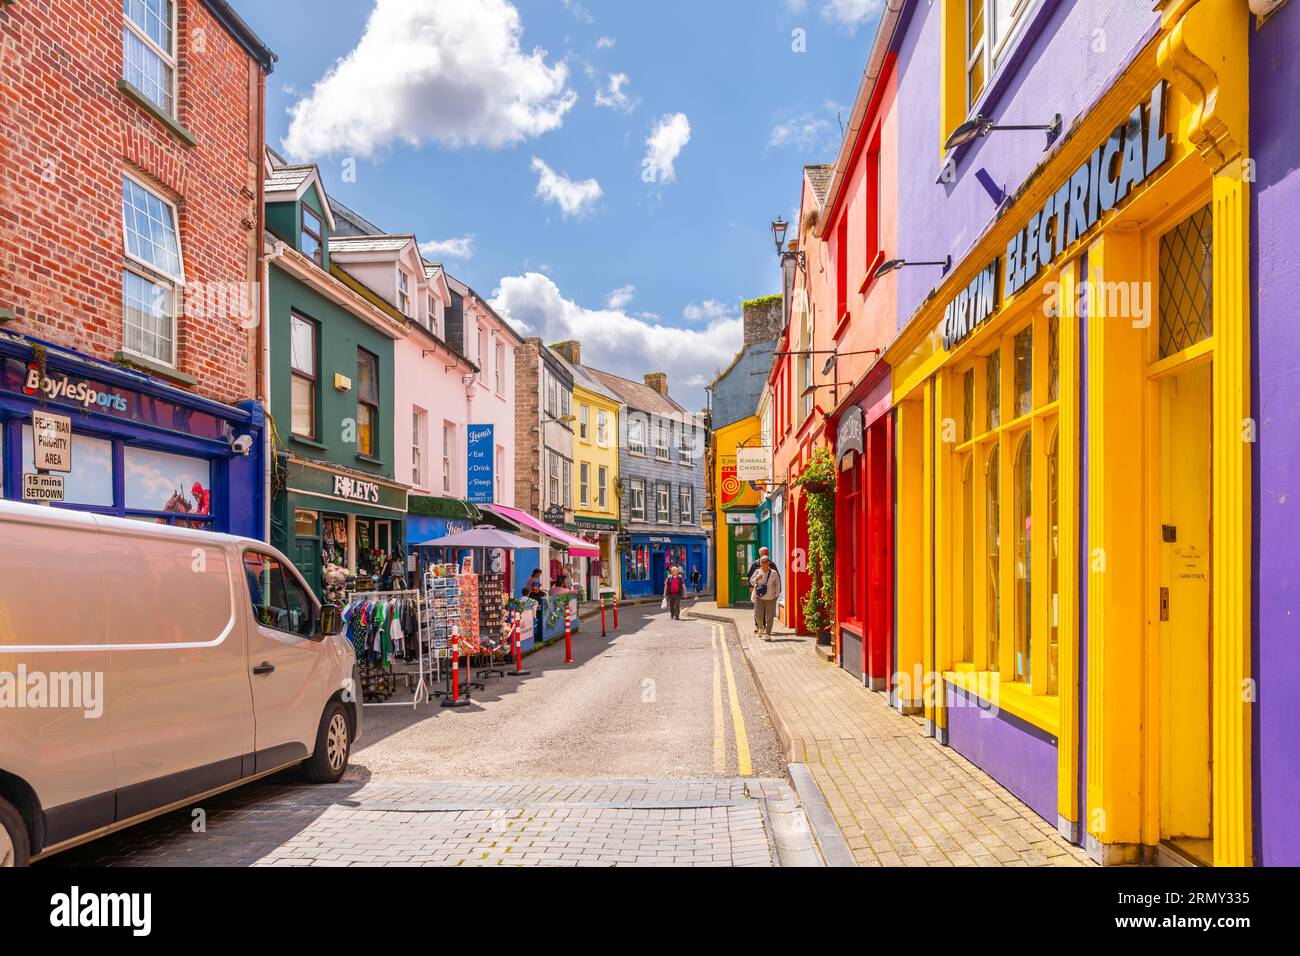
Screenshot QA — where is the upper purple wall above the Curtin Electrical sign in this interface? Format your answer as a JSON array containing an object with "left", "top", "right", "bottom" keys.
[{"left": 885, "top": 0, "right": 1160, "bottom": 329}]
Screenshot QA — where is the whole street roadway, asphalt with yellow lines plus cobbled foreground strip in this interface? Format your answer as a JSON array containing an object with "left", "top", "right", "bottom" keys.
[{"left": 48, "top": 606, "right": 822, "bottom": 866}]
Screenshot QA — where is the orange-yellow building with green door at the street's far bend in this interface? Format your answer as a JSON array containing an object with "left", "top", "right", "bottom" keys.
[{"left": 711, "top": 415, "right": 762, "bottom": 607}]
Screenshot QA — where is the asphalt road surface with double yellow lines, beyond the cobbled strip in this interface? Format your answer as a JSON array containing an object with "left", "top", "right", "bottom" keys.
[{"left": 345, "top": 602, "right": 785, "bottom": 782}]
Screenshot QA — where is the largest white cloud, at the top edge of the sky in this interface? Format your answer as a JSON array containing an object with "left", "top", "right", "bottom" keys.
[{"left": 283, "top": 0, "right": 577, "bottom": 157}]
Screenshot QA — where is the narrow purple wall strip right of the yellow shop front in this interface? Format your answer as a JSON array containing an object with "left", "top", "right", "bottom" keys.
[{"left": 1251, "top": 3, "right": 1300, "bottom": 866}]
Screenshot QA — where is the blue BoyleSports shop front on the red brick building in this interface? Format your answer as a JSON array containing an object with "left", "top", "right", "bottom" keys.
[{"left": 0, "top": 334, "right": 265, "bottom": 540}]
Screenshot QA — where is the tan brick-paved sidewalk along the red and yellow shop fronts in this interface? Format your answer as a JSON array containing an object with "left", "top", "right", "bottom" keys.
[{"left": 688, "top": 602, "right": 1091, "bottom": 866}]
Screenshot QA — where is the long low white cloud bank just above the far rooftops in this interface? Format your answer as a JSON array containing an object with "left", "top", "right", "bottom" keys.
[{"left": 491, "top": 272, "right": 744, "bottom": 410}]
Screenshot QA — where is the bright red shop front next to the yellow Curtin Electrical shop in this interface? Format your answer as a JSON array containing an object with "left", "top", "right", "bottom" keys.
[{"left": 831, "top": 363, "right": 894, "bottom": 691}]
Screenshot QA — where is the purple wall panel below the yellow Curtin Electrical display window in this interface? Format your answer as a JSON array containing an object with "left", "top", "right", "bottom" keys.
[{"left": 945, "top": 684, "right": 1057, "bottom": 826}]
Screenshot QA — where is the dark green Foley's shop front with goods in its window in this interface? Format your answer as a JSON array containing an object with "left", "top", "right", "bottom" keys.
[{"left": 272, "top": 455, "right": 412, "bottom": 602}]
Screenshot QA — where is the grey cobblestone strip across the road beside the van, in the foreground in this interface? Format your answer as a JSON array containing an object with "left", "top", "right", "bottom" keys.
[{"left": 51, "top": 779, "right": 794, "bottom": 866}]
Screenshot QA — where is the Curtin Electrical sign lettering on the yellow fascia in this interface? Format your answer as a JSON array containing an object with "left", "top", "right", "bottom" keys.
[{"left": 939, "top": 81, "right": 1169, "bottom": 349}]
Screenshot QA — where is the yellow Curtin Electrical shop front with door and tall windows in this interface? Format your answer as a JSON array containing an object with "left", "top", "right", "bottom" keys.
[{"left": 885, "top": 29, "right": 1258, "bottom": 865}]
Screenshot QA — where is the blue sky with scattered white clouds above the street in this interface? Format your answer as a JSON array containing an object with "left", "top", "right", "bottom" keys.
[{"left": 237, "top": 0, "right": 879, "bottom": 407}]
